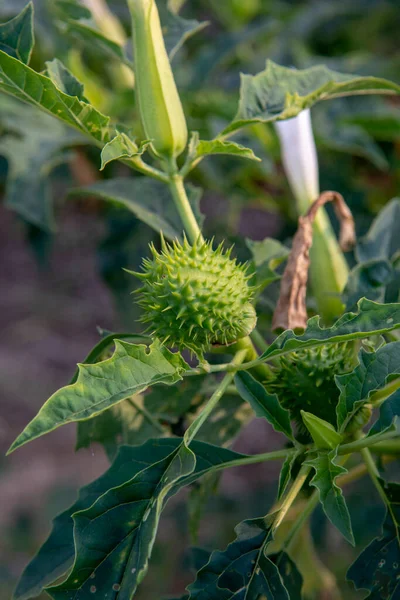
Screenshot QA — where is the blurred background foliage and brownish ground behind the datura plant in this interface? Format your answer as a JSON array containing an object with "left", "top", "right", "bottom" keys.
[{"left": 0, "top": 0, "right": 400, "bottom": 600}]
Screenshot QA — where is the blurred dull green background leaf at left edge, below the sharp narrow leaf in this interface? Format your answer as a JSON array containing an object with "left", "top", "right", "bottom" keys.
[{"left": 0, "top": 95, "right": 86, "bottom": 232}]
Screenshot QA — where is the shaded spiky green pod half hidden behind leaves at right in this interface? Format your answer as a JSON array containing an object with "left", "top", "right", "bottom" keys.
[{"left": 266, "top": 343, "right": 356, "bottom": 442}]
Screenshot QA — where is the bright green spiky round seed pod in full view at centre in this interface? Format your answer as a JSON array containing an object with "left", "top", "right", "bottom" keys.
[{"left": 130, "top": 239, "right": 257, "bottom": 357}]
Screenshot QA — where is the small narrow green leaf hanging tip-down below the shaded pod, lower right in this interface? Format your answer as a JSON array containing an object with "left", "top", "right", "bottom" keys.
[{"left": 304, "top": 449, "right": 354, "bottom": 546}]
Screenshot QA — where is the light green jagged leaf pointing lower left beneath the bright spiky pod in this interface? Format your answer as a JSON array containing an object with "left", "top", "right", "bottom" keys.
[{"left": 9, "top": 340, "right": 188, "bottom": 452}]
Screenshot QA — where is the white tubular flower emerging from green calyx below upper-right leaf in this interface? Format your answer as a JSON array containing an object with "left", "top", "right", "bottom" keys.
[{"left": 275, "top": 109, "right": 319, "bottom": 213}]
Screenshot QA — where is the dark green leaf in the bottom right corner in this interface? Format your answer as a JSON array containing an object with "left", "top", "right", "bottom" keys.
[{"left": 347, "top": 481, "right": 400, "bottom": 600}]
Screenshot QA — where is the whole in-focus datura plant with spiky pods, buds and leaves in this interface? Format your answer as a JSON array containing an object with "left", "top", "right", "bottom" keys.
[{"left": 0, "top": 0, "right": 400, "bottom": 600}]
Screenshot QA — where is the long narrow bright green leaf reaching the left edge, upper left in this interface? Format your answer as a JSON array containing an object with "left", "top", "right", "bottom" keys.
[{"left": 0, "top": 51, "right": 110, "bottom": 144}]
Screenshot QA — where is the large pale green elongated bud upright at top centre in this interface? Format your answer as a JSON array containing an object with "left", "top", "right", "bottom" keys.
[{"left": 128, "top": 0, "right": 187, "bottom": 159}]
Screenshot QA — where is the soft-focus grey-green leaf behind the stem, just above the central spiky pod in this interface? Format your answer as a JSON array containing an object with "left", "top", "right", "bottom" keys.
[{"left": 73, "top": 177, "right": 202, "bottom": 239}]
